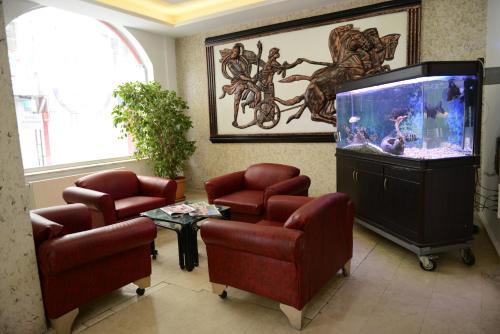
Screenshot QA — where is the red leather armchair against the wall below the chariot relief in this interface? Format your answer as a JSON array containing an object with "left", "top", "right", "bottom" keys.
[{"left": 205, "top": 163, "right": 311, "bottom": 223}]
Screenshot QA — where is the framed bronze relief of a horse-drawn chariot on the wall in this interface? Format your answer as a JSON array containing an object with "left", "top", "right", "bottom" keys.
[{"left": 205, "top": 0, "right": 420, "bottom": 143}]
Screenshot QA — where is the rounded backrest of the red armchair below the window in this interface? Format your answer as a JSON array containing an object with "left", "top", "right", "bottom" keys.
[{"left": 75, "top": 170, "right": 139, "bottom": 200}]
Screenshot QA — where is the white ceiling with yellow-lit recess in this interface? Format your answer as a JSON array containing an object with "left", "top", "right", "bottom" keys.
[{"left": 27, "top": 0, "right": 342, "bottom": 37}]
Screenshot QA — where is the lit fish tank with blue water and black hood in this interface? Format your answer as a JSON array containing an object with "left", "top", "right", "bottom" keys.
[{"left": 336, "top": 61, "right": 482, "bottom": 159}]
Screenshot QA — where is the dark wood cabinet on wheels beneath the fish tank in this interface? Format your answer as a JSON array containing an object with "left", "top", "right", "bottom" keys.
[{"left": 336, "top": 148, "right": 479, "bottom": 270}]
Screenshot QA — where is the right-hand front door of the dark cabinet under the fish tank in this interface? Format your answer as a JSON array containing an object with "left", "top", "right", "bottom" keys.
[{"left": 383, "top": 168, "right": 422, "bottom": 242}]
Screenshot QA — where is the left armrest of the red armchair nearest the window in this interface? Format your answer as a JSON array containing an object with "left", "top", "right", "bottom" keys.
[{"left": 63, "top": 187, "right": 116, "bottom": 225}]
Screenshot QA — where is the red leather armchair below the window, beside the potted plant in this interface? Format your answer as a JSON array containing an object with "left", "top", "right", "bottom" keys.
[{"left": 63, "top": 170, "right": 177, "bottom": 227}]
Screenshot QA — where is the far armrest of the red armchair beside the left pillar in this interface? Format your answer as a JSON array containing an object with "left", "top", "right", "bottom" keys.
[{"left": 31, "top": 204, "right": 92, "bottom": 235}]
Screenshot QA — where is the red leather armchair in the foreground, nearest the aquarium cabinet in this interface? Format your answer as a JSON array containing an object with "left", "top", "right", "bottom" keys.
[{"left": 201, "top": 193, "right": 354, "bottom": 329}]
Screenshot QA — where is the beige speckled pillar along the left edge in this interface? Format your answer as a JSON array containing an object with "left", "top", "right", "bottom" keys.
[{"left": 0, "top": 1, "right": 46, "bottom": 333}]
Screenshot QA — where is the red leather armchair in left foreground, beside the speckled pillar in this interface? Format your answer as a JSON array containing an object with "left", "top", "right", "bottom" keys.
[{"left": 30, "top": 204, "right": 156, "bottom": 333}]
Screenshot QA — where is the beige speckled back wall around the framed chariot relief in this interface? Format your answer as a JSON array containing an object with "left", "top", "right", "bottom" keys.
[{"left": 176, "top": 0, "right": 487, "bottom": 195}]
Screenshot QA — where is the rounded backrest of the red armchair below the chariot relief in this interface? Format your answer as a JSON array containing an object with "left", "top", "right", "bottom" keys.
[{"left": 244, "top": 163, "right": 300, "bottom": 190}]
